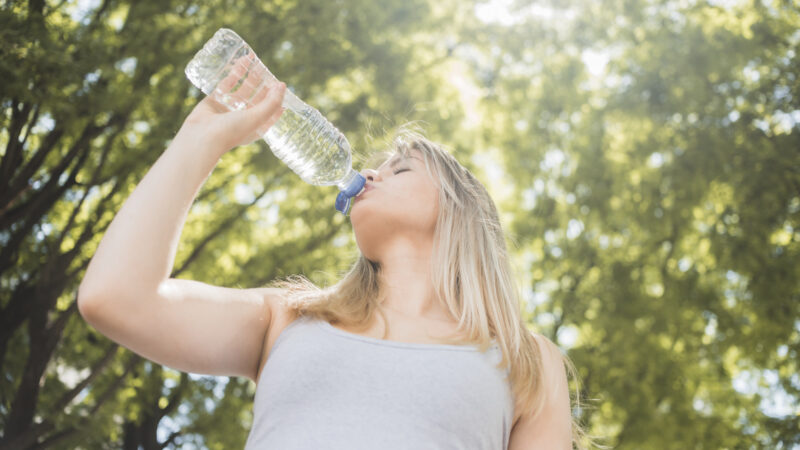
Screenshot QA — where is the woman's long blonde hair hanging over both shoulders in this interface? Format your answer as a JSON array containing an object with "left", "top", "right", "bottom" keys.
[{"left": 272, "top": 133, "right": 584, "bottom": 449}]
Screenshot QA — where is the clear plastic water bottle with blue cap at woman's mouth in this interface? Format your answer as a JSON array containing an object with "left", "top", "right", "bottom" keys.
[{"left": 186, "top": 28, "right": 366, "bottom": 214}]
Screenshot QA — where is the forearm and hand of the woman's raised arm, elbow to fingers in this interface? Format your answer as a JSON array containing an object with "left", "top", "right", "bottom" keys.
[{"left": 78, "top": 83, "right": 286, "bottom": 307}]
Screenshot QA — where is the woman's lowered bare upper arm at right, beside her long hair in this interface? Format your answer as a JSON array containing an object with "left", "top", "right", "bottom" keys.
[{"left": 508, "top": 334, "right": 572, "bottom": 450}]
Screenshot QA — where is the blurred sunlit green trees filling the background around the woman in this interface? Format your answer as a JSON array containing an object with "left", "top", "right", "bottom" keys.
[{"left": 0, "top": 0, "right": 800, "bottom": 450}]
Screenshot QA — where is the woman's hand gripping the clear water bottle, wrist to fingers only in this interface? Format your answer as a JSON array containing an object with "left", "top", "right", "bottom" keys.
[{"left": 176, "top": 71, "right": 286, "bottom": 157}]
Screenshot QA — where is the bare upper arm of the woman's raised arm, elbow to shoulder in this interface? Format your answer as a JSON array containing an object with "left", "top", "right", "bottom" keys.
[{"left": 79, "top": 278, "right": 281, "bottom": 380}]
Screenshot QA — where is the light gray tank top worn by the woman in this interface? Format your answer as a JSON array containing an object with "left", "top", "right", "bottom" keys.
[{"left": 245, "top": 317, "right": 514, "bottom": 450}]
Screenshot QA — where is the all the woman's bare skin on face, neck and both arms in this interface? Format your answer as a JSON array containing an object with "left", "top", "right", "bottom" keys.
[{"left": 78, "top": 71, "right": 570, "bottom": 450}]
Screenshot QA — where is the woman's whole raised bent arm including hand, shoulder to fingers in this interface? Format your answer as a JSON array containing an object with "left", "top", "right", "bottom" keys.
[{"left": 78, "top": 80, "right": 285, "bottom": 379}]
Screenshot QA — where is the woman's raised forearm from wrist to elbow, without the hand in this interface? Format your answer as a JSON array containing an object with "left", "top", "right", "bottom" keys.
[{"left": 79, "top": 132, "right": 223, "bottom": 300}]
